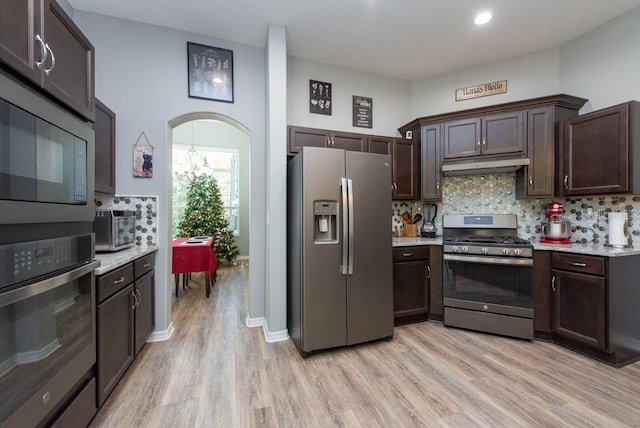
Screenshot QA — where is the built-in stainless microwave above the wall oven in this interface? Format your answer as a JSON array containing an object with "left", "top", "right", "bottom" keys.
[{"left": 0, "top": 73, "right": 95, "bottom": 224}]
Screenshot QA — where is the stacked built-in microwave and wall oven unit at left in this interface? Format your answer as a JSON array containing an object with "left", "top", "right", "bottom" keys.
[{"left": 0, "top": 73, "right": 99, "bottom": 428}]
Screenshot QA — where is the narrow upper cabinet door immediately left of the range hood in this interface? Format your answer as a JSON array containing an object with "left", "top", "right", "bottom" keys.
[{"left": 420, "top": 124, "right": 442, "bottom": 201}]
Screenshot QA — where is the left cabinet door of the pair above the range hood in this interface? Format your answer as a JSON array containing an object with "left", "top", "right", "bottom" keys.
[{"left": 443, "top": 117, "right": 481, "bottom": 159}]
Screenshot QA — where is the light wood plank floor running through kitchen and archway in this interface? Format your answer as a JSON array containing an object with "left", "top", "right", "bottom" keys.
[{"left": 91, "top": 265, "right": 640, "bottom": 428}]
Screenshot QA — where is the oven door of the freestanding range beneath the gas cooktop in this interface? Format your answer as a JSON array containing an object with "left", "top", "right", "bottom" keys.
[{"left": 442, "top": 254, "right": 533, "bottom": 318}]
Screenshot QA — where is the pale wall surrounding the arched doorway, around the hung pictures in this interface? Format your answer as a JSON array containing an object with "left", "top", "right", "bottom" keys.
[{"left": 73, "top": 11, "right": 265, "bottom": 331}]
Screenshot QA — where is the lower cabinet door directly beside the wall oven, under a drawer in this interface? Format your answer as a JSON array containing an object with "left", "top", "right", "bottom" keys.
[{"left": 96, "top": 284, "right": 134, "bottom": 406}]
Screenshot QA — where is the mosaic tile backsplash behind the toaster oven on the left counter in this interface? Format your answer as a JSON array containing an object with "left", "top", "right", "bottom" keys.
[{"left": 96, "top": 195, "right": 158, "bottom": 247}]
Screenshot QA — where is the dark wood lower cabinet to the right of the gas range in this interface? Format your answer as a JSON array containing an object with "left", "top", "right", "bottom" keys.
[{"left": 534, "top": 251, "right": 640, "bottom": 366}]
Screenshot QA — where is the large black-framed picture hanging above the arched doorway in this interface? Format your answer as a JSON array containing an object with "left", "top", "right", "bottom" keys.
[{"left": 187, "top": 42, "right": 233, "bottom": 103}]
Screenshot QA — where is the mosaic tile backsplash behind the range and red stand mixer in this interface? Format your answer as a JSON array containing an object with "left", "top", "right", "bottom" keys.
[{"left": 391, "top": 173, "right": 640, "bottom": 246}]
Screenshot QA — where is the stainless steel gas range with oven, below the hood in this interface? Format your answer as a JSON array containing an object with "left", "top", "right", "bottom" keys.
[{"left": 442, "top": 214, "right": 533, "bottom": 339}]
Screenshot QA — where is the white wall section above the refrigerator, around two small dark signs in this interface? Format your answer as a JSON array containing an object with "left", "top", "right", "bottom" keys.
[{"left": 287, "top": 56, "right": 413, "bottom": 137}]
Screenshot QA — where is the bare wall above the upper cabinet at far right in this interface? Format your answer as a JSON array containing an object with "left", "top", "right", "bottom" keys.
[{"left": 560, "top": 7, "right": 640, "bottom": 113}]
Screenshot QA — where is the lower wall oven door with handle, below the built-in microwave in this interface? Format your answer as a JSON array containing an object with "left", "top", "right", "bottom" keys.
[{"left": 0, "top": 261, "right": 100, "bottom": 427}]
